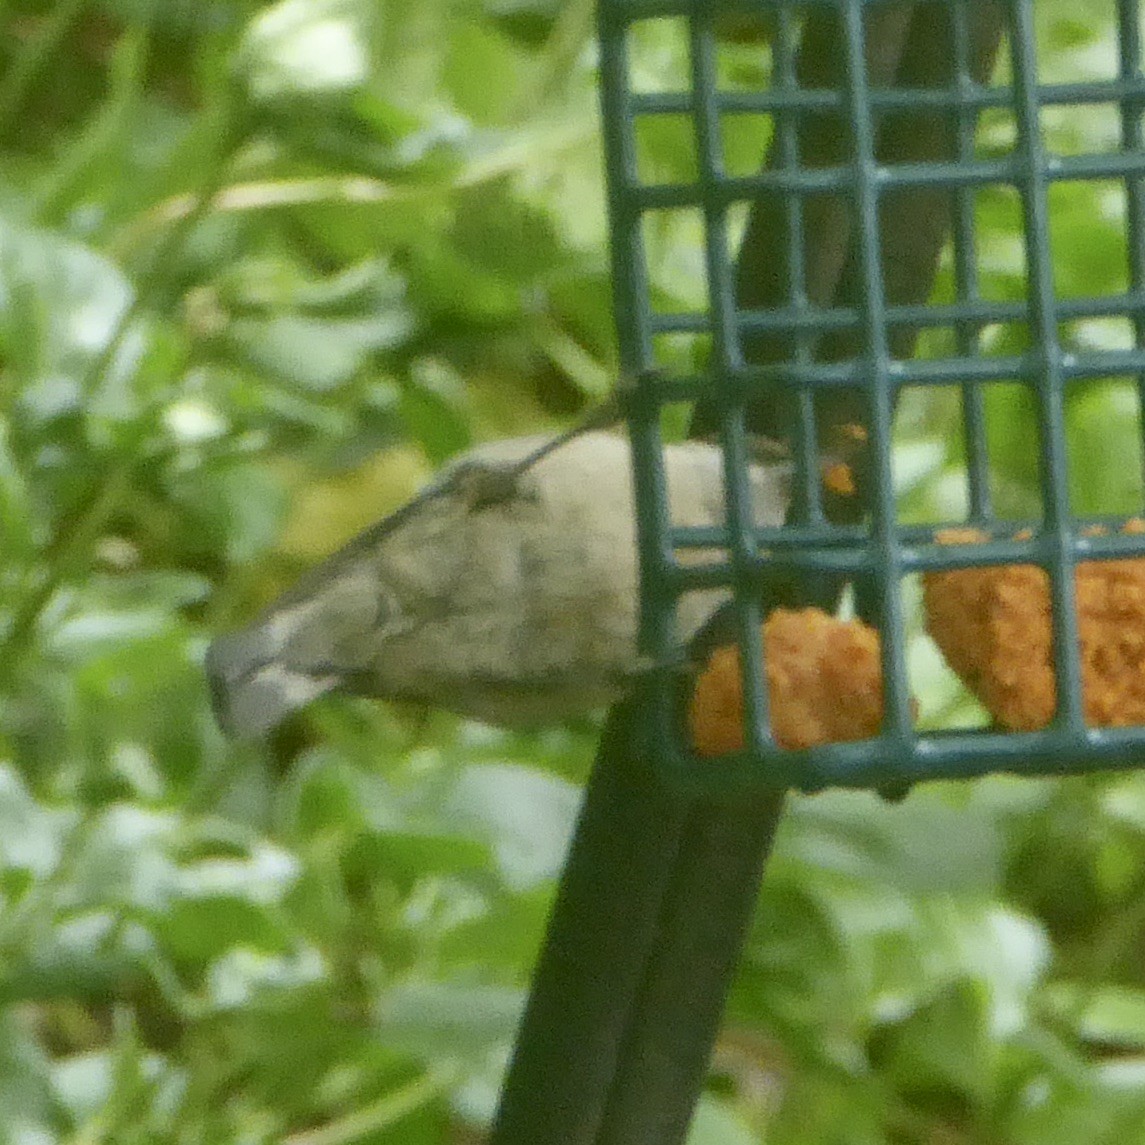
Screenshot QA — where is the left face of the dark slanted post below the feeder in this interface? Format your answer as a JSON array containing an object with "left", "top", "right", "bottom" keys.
[{"left": 489, "top": 702, "right": 686, "bottom": 1145}]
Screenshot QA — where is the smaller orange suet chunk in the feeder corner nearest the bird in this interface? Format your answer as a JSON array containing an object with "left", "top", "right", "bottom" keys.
[{"left": 688, "top": 608, "right": 883, "bottom": 756}]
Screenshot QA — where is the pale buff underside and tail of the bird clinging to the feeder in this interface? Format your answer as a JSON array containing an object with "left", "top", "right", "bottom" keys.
[{"left": 206, "top": 432, "right": 789, "bottom": 736}]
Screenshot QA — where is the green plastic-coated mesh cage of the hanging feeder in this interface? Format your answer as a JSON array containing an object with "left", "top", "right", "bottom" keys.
[{"left": 599, "top": 0, "right": 1145, "bottom": 790}]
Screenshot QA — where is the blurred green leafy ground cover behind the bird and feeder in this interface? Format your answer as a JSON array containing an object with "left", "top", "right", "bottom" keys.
[{"left": 0, "top": 0, "right": 1145, "bottom": 1145}]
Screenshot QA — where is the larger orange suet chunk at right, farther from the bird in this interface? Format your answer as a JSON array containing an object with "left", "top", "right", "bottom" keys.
[{"left": 923, "top": 520, "right": 1145, "bottom": 731}]
